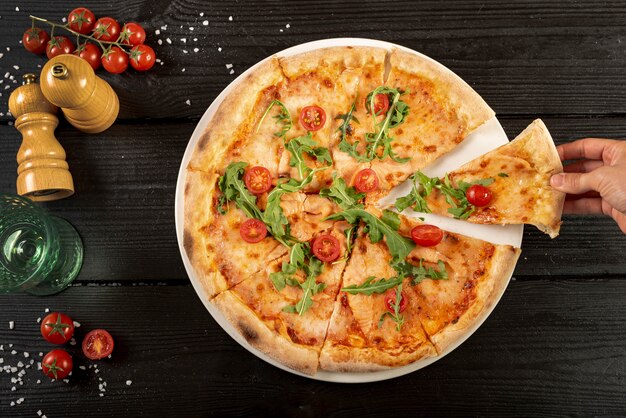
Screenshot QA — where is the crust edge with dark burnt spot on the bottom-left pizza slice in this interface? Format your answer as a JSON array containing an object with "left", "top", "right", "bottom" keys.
[{"left": 211, "top": 291, "right": 319, "bottom": 375}]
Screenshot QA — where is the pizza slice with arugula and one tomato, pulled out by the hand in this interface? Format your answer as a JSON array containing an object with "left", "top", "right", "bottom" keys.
[{"left": 395, "top": 119, "right": 565, "bottom": 238}]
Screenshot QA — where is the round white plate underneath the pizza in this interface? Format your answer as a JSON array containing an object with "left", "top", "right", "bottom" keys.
[{"left": 175, "top": 38, "right": 523, "bottom": 383}]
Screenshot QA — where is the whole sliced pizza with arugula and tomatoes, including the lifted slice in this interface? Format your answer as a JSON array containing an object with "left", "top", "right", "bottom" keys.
[{"left": 183, "top": 47, "right": 563, "bottom": 375}]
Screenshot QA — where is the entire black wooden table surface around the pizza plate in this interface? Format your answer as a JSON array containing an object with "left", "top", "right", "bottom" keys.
[{"left": 0, "top": 0, "right": 626, "bottom": 417}]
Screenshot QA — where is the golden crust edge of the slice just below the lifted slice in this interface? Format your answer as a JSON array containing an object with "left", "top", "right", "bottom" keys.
[{"left": 430, "top": 245, "right": 521, "bottom": 354}]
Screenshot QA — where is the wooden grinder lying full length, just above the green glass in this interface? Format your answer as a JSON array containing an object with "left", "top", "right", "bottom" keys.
[{"left": 9, "top": 74, "right": 74, "bottom": 201}]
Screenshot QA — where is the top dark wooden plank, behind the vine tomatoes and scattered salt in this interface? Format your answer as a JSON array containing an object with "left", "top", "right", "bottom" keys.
[{"left": 0, "top": 0, "right": 626, "bottom": 121}]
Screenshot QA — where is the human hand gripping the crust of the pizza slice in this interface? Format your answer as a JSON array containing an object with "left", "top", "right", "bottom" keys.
[{"left": 550, "top": 138, "right": 626, "bottom": 234}]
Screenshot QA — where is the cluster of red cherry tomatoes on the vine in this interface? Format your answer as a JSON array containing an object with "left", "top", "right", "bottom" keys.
[{"left": 22, "top": 7, "right": 156, "bottom": 74}]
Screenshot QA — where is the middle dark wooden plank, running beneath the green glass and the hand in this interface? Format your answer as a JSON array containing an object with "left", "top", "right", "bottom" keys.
[{"left": 0, "top": 117, "right": 626, "bottom": 281}]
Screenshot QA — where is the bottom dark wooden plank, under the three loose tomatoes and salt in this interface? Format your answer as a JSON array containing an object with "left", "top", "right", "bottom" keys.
[{"left": 0, "top": 276, "right": 626, "bottom": 417}]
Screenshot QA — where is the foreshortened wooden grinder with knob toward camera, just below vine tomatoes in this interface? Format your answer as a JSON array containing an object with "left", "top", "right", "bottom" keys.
[{"left": 41, "top": 54, "right": 120, "bottom": 133}]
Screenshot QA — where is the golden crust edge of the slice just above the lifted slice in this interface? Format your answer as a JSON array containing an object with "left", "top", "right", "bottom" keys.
[{"left": 389, "top": 49, "right": 495, "bottom": 133}]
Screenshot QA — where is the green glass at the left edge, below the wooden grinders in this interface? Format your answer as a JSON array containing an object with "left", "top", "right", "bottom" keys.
[{"left": 0, "top": 193, "right": 83, "bottom": 296}]
